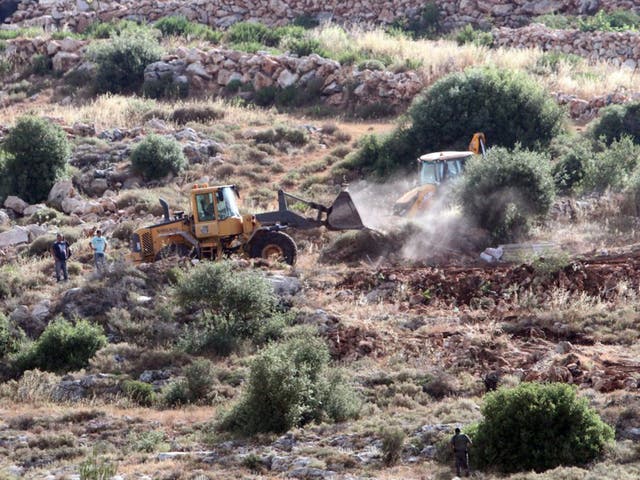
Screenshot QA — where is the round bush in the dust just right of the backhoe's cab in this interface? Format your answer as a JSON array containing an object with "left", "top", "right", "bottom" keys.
[{"left": 459, "top": 148, "right": 555, "bottom": 242}]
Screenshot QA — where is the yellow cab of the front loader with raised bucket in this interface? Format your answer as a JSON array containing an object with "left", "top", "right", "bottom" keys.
[{"left": 191, "top": 185, "right": 243, "bottom": 239}]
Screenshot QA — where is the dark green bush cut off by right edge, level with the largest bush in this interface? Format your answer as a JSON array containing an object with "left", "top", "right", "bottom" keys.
[{"left": 591, "top": 102, "right": 640, "bottom": 145}]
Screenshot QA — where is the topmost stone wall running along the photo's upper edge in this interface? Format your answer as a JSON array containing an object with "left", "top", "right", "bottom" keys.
[{"left": 7, "top": 0, "right": 640, "bottom": 31}]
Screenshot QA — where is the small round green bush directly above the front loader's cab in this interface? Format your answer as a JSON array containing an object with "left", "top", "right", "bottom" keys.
[{"left": 131, "top": 134, "right": 187, "bottom": 179}]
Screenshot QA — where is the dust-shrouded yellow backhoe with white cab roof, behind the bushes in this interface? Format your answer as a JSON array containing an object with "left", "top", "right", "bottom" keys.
[{"left": 393, "top": 132, "right": 485, "bottom": 218}]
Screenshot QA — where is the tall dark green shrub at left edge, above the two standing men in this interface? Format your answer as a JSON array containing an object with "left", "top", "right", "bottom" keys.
[{"left": 4, "top": 117, "right": 71, "bottom": 203}]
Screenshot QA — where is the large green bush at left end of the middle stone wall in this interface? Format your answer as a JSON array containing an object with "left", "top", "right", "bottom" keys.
[{"left": 89, "top": 30, "right": 162, "bottom": 93}]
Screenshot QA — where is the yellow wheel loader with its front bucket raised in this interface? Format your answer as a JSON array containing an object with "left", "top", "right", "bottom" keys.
[{"left": 131, "top": 184, "right": 364, "bottom": 265}]
